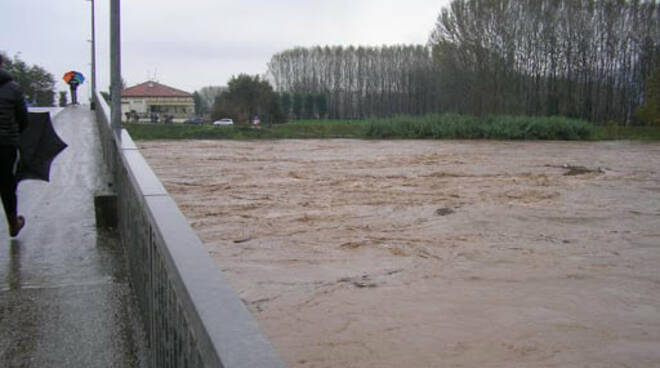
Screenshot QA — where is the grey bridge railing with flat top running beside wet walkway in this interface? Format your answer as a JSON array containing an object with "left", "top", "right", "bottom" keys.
[{"left": 96, "top": 94, "right": 284, "bottom": 368}]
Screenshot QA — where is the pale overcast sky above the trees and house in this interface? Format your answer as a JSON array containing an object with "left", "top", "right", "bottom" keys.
[{"left": 0, "top": 0, "right": 449, "bottom": 99}]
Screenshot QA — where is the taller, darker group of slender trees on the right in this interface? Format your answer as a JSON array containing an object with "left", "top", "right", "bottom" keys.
[{"left": 430, "top": 0, "right": 660, "bottom": 122}]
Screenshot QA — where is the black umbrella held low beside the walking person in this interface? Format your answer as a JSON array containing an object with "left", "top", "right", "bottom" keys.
[{"left": 16, "top": 112, "right": 67, "bottom": 181}]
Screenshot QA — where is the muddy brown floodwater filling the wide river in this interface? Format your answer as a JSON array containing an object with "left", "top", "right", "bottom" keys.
[{"left": 140, "top": 140, "right": 660, "bottom": 368}]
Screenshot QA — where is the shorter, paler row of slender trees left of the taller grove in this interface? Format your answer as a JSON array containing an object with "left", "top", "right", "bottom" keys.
[{"left": 268, "top": 45, "right": 435, "bottom": 119}]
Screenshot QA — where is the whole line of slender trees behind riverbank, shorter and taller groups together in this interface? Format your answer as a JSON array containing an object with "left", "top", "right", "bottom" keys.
[{"left": 268, "top": 0, "right": 660, "bottom": 123}]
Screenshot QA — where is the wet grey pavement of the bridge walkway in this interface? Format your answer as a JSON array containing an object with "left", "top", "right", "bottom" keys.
[{"left": 0, "top": 106, "right": 143, "bottom": 368}]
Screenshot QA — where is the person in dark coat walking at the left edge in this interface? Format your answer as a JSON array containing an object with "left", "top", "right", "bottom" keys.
[{"left": 0, "top": 55, "right": 28, "bottom": 237}]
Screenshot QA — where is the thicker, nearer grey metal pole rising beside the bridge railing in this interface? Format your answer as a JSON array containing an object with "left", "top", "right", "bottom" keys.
[{"left": 110, "top": 0, "right": 121, "bottom": 130}]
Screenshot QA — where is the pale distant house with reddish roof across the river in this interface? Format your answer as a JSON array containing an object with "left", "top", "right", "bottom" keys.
[{"left": 121, "top": 81, "right": 195, "bottom": 122}]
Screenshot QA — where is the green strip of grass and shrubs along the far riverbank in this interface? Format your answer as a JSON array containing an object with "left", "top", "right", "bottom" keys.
[{"left": 125, "top": 114, "right": 660, "bottom": 140}]
